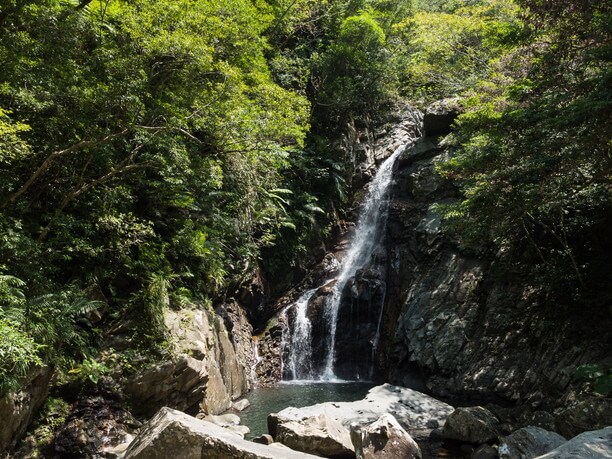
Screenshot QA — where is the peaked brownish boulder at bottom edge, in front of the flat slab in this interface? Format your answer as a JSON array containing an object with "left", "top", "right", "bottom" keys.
[{"left": 351, "top": 414, "right": 422, "bottom": 459}]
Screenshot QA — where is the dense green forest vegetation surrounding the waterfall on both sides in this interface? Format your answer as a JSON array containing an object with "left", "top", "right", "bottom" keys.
[{"left": 0, "top": 0, "right": 612, "bottom": 398}]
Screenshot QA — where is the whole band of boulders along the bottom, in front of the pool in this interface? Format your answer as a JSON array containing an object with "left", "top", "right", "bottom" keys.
[{"left": 98, "top": 384, "right": 612, "bottom": 459}]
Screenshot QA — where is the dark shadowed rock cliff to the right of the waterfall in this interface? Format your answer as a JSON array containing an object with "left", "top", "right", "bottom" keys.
[{"left": 378, "top": 113, "right": 611, "bottom": 404}]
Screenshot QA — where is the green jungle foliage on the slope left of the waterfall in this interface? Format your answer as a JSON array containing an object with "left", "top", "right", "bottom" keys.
[{"left": 0, "top": 0, "right": 410, "bottom": 392}]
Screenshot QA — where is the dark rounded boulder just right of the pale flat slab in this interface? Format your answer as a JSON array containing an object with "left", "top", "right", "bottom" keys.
[{"left": 442, "top": 406, "right": 499, "bottom": 444}]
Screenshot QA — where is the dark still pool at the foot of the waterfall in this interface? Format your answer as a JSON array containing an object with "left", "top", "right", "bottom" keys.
[{"left": 238, "top": 381, "right": 374, "bottom": 439}]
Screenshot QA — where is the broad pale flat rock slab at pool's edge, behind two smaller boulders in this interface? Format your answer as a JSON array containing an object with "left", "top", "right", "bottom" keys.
[{"left": 268, "top": 384, "right": 454, "bottom": 436}]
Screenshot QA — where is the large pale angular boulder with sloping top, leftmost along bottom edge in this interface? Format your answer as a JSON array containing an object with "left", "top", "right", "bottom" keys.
[{"left": 125, "top": 407, "right": 316, "bottom": 459}]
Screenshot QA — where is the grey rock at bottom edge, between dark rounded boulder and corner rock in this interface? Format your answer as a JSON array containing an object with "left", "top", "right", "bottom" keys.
[{"left": 499, "top": 426, "right": 567, "bottom": 459}]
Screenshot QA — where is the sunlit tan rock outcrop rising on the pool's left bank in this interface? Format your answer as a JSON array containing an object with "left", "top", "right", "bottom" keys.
[{"left": 125, "top": 302, "right": 254, "bottom": 415}]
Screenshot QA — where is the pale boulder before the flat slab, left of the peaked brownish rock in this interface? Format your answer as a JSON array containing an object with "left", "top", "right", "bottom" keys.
[{"left": 276, "top": 414, "right": 355, "bottom": 458}]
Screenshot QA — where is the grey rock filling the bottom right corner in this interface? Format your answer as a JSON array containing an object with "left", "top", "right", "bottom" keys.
[{"left": 536, "top": 427, "right": 612, "bottom": 459}]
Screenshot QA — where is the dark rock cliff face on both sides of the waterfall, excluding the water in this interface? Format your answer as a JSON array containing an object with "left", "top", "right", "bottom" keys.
[{"left": 274, "top": 103, "right": 612, "bottom": 410}]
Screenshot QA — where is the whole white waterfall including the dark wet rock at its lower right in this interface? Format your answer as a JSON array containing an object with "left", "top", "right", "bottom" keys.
[{"left": 282, "top": 136, "right": 416, "bottom": 381}]
